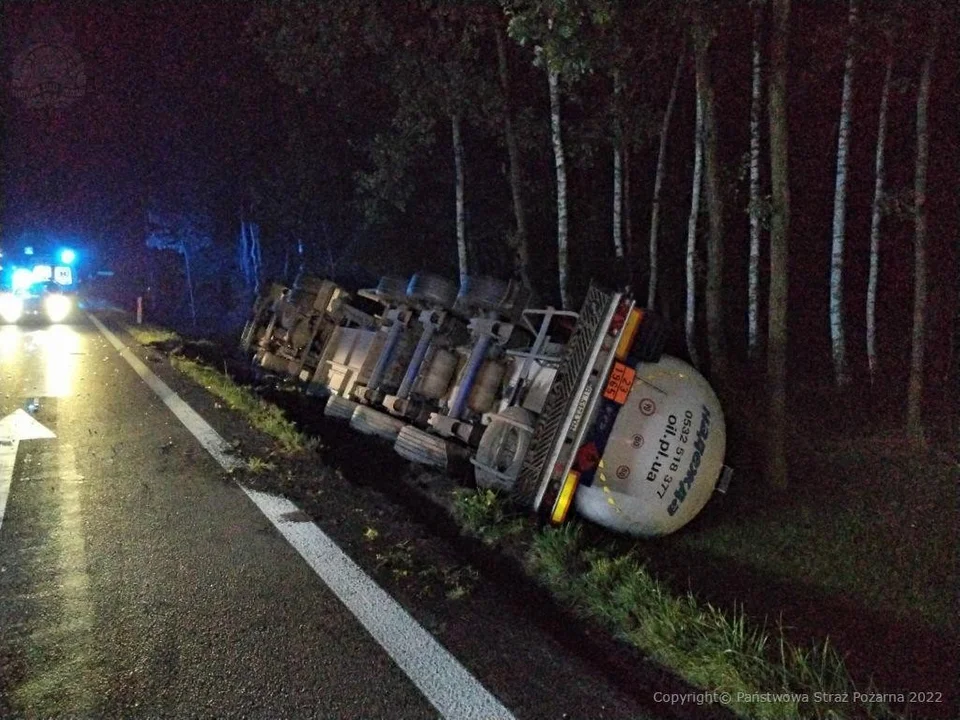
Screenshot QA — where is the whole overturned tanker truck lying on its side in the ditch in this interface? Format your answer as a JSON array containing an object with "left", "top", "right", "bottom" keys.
[{"left": 242, "top": 273, "right": 731, "bottom": 537}]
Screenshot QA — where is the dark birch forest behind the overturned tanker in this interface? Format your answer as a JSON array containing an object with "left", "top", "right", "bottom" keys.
[{"left": 7, "top": 0, "right": 960, "bottom": 466}]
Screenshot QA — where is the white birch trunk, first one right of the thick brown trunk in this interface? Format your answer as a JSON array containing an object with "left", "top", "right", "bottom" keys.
[{"left": 830, "top": 0, "right": 857, "bottom": 387}]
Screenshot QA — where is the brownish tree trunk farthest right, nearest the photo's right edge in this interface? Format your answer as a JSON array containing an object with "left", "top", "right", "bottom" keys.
[{"left": 907, "top": 26, "right": 937, "bottom": 443}]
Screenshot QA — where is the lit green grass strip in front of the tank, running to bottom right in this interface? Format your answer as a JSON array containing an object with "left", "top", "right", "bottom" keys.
[{"left": 527, "top": 523, "right": 900, "bottom": 720}]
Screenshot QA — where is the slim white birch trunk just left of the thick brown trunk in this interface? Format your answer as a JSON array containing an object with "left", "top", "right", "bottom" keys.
[{"left": 747, "top": 5, "right": 763, "bottom": 360}]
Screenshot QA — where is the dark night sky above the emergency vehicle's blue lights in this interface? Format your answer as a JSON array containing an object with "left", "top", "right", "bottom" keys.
[{"left": 2, "top": 3, "right": 289, "bottom": 278}]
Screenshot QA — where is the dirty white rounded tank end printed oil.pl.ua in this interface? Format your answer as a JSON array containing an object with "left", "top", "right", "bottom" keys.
[{"left": 575, "top": 356, "right": 726, "bottom": 537}]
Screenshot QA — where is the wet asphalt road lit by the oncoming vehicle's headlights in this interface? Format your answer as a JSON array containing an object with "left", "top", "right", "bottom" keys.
[{"left": 0, "top": 320, "right": 736, "bottom": 718}]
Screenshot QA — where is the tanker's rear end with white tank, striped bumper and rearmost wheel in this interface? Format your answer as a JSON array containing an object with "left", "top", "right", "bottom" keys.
[{"left": 472, "top": 285, "right": 730, "bottom": 537}]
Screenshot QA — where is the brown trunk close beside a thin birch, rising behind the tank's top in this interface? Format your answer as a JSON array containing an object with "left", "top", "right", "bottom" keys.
[{"left": 696, "top": 20, "right": 727, "bottom": 380}]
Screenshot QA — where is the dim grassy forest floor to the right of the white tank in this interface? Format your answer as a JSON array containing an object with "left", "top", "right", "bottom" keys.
[{"left": 669, "top": 436, "right": 960, "bottom": 632}]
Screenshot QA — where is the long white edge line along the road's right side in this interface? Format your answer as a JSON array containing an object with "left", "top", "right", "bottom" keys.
[{"left": 88, "top": 313, "right": 514, "bottom": 720}]
